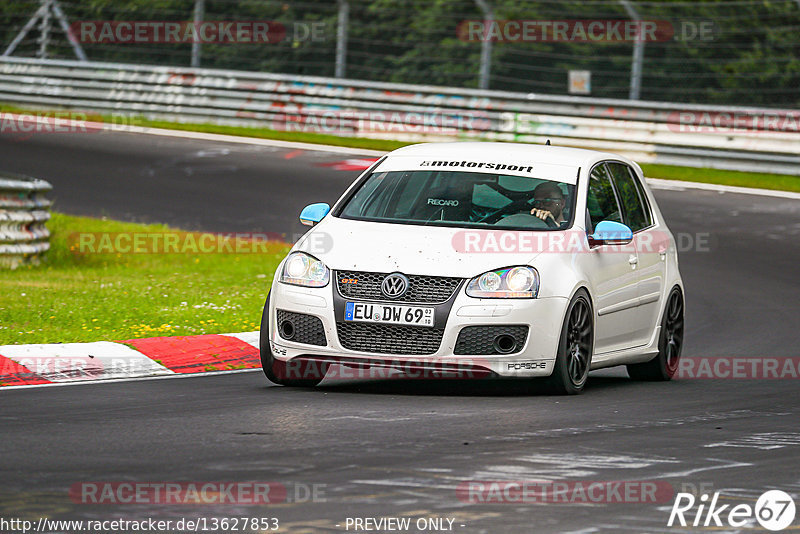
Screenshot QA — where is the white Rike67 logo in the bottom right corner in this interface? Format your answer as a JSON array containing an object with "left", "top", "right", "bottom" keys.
[{"left": 667, "top": 490, "right": 795, "bottom": 532}]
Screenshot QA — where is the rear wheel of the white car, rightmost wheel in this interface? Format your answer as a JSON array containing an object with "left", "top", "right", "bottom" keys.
[{"left": 627, "top": 287, "right": 683, "bottom": 382}]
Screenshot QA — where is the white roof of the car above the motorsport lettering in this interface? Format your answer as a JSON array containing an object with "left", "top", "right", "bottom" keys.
[{"left": 388, "top": 141, "right": 629, "bottom": 167}]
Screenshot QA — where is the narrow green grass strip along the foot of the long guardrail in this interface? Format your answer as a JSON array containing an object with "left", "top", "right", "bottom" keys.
[{"left": 0, "top": 104, "right": 800, "bottom": 192}]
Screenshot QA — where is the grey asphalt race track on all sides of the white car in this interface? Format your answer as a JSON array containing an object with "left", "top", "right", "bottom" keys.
[{"left": 0, "top": 133, "right": 800, "bottom": 533}]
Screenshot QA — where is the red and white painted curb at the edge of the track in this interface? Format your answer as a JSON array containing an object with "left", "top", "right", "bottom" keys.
[{"left": 0, "top": 332, "right": 261, "bottom": 387}]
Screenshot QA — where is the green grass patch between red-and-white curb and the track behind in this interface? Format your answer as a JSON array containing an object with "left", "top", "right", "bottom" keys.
[{"left": 0, "top": 213, "right": 289, "bottom": 345}]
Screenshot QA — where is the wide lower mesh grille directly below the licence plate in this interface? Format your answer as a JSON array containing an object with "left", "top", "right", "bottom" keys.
[{"left": 336, "top": 323, "right": 444, "bottom": 354}]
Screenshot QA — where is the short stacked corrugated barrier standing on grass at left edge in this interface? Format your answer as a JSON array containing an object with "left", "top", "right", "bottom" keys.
[{"left": 0, "top": 173, "right": 53, "bottom": 269}]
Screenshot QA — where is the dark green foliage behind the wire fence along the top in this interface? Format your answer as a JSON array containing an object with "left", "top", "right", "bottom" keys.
[{"left": 0, "top": 0, "right": 800, "bottom": 107}]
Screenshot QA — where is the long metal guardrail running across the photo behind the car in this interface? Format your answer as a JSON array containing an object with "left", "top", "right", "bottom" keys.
[{"left": 0, "top": 57, "right": 800, "bottom": 175}]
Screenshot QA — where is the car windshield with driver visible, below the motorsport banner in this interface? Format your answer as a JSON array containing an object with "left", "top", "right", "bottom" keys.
[{"left": 339, "top": 171, "right": 575, "bottom": 230}]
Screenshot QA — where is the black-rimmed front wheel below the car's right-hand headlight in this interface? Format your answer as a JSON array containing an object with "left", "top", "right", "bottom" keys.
[{"left": 547, "top": 289, "right": 594, "bottom": 395}]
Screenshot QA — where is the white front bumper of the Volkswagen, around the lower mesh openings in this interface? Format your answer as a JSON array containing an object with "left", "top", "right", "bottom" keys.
[{"left": 269, "top": 281, "right": 569, "bottom": 377}]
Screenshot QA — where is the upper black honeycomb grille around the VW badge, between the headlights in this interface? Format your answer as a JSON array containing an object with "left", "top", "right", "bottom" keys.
[{"left": 336, "top": 271, "right": 461, "bottom": 304}]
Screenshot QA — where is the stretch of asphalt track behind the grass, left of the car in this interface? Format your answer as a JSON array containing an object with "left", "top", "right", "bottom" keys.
[{"left": 0, "top": 129, "right": 368, "bottom": 240}]
